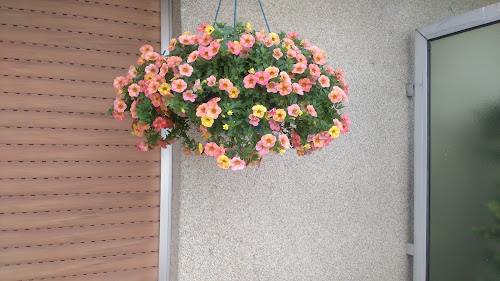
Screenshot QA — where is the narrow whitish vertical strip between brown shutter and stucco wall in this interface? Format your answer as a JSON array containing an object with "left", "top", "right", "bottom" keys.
[{"left": 158, "top": 0, "right": 172, "bottom": 281}]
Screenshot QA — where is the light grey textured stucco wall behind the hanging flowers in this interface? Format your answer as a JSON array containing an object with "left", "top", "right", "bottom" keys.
[{"left": 173, "top": 0, "right": 495, "bottom": 281}]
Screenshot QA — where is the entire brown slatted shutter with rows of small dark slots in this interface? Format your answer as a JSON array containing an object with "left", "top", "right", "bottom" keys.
[{"left": 0, "top": 0, "right": 160, "bottom": 281}]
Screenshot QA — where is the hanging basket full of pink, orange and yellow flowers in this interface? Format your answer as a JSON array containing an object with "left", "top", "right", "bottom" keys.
[{"left": 109, "top": 22, "right": 350, "bottom": 170}]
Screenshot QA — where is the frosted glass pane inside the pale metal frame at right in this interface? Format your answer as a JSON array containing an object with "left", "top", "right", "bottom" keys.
[{"left": 429, "top": 23, "right": 500, "bottom": 281}]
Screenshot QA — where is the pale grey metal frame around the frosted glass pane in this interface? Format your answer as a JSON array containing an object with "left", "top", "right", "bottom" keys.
[{"left": 413, "top": 3, "right": 500, "bottom": 281}]
